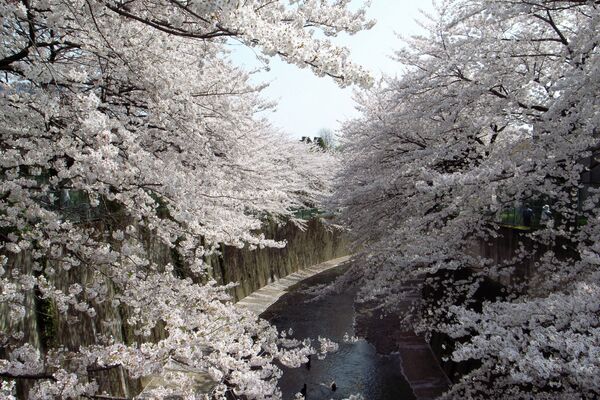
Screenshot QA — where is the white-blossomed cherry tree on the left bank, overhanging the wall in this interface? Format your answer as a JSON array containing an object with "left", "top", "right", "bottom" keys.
[{"left": 0, "top": 0, "right": 371, "bottom": 399}]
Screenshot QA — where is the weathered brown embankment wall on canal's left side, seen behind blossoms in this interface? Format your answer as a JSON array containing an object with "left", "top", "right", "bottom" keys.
[{"left": 0, "top": 219, "right": 349, "bottom": 399}]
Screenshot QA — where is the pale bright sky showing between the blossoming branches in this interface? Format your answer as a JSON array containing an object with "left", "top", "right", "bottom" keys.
[{"left": 230, "top": 0, "right": 432, "bottom": 138}]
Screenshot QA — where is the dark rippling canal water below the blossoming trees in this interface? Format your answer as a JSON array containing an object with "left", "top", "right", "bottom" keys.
[{"left": 261, "top": 267, "right": 415, "bottom": 400}]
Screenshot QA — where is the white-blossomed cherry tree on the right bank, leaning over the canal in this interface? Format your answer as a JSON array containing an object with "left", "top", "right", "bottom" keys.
[{"left": 336, "top": 0, "right": 600, "bottom": 399}]
